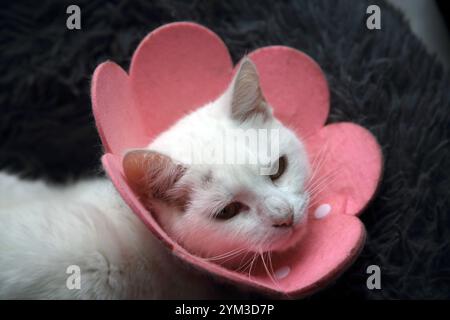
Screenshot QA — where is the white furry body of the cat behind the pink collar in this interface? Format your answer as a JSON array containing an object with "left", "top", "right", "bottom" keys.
[{"left": 0, "top": 173, "right": 220, "bottom": 299}]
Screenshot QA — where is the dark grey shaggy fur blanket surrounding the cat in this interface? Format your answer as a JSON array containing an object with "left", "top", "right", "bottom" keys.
[{"left": 0, "top": 0, "right": 450, "bottom": 299}]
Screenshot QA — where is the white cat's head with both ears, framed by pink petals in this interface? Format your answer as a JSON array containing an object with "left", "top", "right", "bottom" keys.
[{"left": 123, "top": 59, "right": 309, "bottom": 257}]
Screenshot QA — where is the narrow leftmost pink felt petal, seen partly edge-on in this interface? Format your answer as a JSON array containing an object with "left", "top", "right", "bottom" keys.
[{"left": 91, "top": 62, "right": 146, "bottom": 154}]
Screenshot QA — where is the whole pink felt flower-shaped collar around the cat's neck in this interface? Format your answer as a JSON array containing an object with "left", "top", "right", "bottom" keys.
[{"left": 92, "top": 22, "right": 382, "bottom": 297}]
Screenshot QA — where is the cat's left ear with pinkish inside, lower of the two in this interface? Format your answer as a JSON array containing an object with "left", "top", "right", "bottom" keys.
[{"left": 122, "top": 150, "right": 186, "bottom": 206}]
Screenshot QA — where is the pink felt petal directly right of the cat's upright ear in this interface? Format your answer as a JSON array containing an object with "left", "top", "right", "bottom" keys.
[{"left": 249, "top": 46, "right": 329, "bottom": 137}]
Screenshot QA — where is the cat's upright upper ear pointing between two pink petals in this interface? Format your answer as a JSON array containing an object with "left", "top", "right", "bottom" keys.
[{"left": 230, "top": 58, "right": 272, "bottom": 122}]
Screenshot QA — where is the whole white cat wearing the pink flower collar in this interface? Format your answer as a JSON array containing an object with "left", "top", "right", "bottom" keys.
[{"left": 0, "top": 59, "right": 309, "bottom": 299}]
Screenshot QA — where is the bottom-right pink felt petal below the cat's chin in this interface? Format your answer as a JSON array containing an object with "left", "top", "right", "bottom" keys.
[{"left": 273, "top": 212, "right": 365, "bottom": 296}]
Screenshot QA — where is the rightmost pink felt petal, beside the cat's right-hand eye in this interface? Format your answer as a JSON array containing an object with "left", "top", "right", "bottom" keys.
[{"left": 306, "top": 123, "right": 382, "bottom": 214}]
